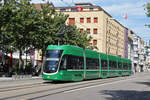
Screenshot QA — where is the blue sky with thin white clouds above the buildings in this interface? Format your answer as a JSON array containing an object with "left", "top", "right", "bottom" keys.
[{"left": 32, "top": 0, "right": 150, "bottom": 42}]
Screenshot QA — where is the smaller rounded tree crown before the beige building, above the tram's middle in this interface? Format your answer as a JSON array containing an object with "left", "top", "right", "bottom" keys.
[{"left": 60, "top": 25, "right": 92, "bottom": 48}]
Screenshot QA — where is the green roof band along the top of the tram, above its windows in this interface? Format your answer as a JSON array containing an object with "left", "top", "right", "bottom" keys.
[{"left": 47, "top": 45, "right": 131, "bottom": 62}]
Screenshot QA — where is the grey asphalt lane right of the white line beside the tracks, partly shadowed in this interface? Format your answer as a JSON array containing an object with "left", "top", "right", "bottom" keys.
[{"left": 36, "top": 73, "right": 150, "bottom": 100}]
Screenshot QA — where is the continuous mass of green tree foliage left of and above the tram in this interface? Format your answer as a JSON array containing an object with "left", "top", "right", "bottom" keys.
[{"left": 0, "top": 0, "right": 94, "bottom": 72}]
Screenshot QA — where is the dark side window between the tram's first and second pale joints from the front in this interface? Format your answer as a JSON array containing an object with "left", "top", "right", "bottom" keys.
[{"left": 86, "top": 58, "right": 99, "bottom": 69}]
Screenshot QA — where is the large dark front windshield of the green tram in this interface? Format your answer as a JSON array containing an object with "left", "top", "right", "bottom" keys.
[{"left": 43, "top": 50, "right": 62, "bottom": 73}]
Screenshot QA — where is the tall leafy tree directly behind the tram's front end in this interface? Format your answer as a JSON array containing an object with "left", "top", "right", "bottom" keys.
[{"left": 32, "top": 2, "right": 65, "bottom": 60}]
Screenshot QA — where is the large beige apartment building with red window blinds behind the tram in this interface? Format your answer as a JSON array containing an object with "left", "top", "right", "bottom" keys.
[{"left": 55, "top": 3, "right": 127, "bottom": 57}]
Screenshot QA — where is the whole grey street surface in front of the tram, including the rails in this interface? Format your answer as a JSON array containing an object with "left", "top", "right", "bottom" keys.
[{"left": 0, "top": 73, "right": 150, "bottom": 100}]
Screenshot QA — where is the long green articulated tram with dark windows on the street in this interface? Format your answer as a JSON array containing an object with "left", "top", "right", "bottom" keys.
[{"left": 42, "top": 45, "right": 131, "bottom": 81}]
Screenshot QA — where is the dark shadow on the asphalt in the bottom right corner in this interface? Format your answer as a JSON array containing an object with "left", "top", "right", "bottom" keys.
[{"left": 99, "top": 90, "right": 150, "bottom": 100}]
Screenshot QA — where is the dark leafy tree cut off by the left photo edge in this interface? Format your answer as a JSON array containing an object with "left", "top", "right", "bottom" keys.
[{"left": 0, "top": 0, "right": 15, "bottom": 54}]
